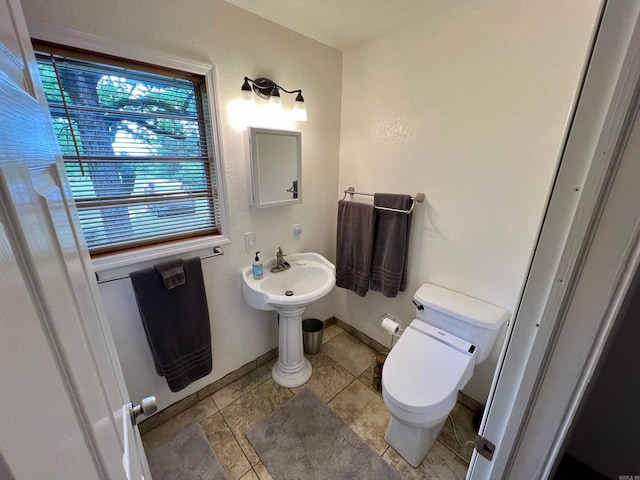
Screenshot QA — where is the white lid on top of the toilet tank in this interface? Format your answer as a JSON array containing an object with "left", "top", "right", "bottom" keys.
[{"left": 413, "top": 283, "right": 509, "bottom": 330}]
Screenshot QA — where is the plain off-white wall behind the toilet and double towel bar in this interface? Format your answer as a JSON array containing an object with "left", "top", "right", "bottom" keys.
[{"left": 335, "top": 0, "right": 600, "bottom": 403}]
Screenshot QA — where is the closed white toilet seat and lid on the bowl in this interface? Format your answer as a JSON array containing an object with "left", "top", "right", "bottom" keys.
[{"left": 382, "top": 320, "right": 475, "bottom": 423}]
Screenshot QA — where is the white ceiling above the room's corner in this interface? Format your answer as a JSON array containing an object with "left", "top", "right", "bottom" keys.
[{"left": 226, "top": 0, "right": 477, "bottom": 51}]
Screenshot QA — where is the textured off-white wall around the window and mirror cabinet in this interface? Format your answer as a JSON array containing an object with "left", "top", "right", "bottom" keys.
[{"left": 22, "top": 0, "right": 342, "bottom": 408}]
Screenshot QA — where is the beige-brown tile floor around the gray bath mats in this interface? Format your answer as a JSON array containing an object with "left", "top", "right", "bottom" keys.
[{"left": 142, "top": 324, "right": 475, "bottom": 480}]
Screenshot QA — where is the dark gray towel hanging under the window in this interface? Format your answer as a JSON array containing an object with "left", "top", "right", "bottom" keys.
[{"left": 130, "top": 257, "right": 212, "bottom": 392}]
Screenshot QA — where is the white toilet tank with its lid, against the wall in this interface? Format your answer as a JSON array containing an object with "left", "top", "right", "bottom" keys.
[{"left": 413, "top": 283, "right": 509, "bottom": 364}]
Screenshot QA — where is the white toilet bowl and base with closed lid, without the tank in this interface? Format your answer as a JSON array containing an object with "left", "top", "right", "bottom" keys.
[{"left": 382, "top": 320, "right": 475, "bottom": 467}]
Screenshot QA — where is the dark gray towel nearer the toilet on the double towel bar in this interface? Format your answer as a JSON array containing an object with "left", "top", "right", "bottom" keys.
[{"left": 370, "top": 193, "right": 412, "bottom": 297}]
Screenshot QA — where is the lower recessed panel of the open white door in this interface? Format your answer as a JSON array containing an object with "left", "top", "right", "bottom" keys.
[{"left": 0, "top": 218, "right": 96, "bottom": 479}]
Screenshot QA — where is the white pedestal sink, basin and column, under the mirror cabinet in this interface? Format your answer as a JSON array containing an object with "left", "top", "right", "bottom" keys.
[{"left": 242, "top": 252, "right": 336, "bottom": 387}]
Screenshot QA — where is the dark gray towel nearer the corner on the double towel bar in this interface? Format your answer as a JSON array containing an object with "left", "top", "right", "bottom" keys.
[{"left": 336, "top": 200, "right": 376, "bottom": 297}]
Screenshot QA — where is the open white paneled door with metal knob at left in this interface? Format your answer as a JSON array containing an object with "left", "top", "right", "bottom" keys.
[{"left": 0, "top": 0, "right": 150, "bottom": 480}]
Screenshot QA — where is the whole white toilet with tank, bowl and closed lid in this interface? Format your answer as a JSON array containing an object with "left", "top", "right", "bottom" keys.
[{"left": 382, "top": 283, "right": 509, "bottom": 467}]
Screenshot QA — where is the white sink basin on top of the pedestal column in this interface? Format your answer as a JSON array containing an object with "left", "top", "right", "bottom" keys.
[{"left": 242, "top": 253, "right": 336, "bottom": 310}]
